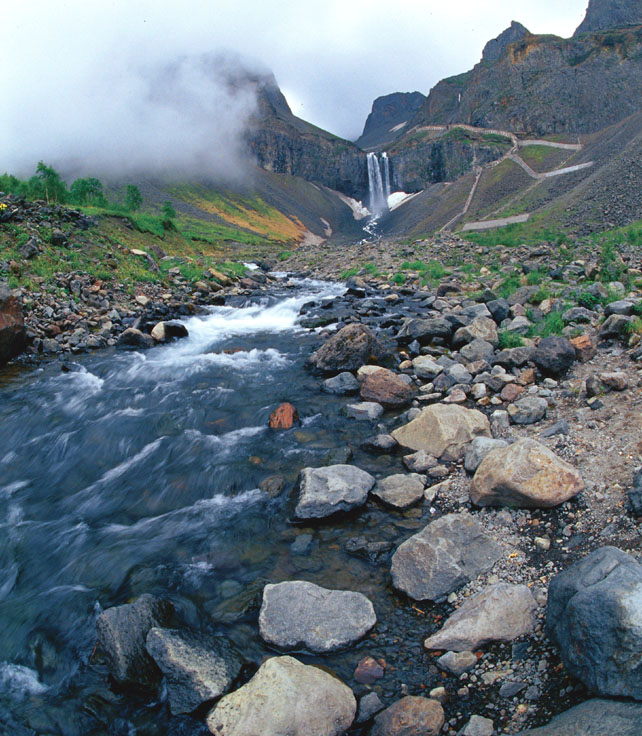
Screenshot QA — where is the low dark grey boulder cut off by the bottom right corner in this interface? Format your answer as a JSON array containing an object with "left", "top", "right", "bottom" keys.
[{"left": 517, "top": 698, "right": 642, "bottom": 736}]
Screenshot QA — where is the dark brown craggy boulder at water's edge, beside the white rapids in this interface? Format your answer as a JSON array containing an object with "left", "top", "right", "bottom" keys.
[{"left": 308, "top": 324, "right": 391, "bottom": 373}]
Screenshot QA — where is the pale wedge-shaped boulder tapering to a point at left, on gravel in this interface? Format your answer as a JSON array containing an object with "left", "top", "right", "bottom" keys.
[{"left": 424, "top": 583, "right": 537, "bottom": 652}]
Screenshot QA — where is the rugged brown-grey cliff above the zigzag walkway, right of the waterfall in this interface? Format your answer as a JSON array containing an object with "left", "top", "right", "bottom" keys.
[{"left": 412, "top": 26, "right": 642, "bottom": 135}]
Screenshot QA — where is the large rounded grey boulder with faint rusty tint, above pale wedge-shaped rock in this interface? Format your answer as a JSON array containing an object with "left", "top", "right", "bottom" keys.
[{"left": 391, "top": 512, "right": 502, "bottom": 601}]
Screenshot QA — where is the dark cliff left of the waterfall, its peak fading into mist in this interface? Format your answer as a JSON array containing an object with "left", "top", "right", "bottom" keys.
[{"left": 247, "top": 77, "right": 368, "bottom": 199}]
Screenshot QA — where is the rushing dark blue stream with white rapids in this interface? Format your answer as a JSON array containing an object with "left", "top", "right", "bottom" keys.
[{"left": 0, "top": 281, "right": 420, "bottom": 736}]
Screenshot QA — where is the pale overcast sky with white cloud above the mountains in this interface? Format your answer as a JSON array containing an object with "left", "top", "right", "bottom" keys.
[{"left": 0, "top": 0, "right": 587, "bottom": 177}]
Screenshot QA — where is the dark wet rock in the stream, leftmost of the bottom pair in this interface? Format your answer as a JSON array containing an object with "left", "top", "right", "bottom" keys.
[{"left": 96, "top": 594, "right": 173, "bottom": 687}]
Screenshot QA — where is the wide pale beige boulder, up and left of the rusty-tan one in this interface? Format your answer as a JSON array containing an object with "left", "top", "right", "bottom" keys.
[{"left": 392, "top": 404, "right": 490, "bottom": 461}]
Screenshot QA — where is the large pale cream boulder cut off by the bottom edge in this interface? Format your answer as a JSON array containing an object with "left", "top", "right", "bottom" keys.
[{"left": 207, "top": 657, "right": 357, "bottom": 736}]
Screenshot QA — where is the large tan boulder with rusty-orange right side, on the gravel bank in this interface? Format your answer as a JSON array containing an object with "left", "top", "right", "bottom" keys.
[{"left": 470, "top": 439, "right": 584, "bottom": 509}]
